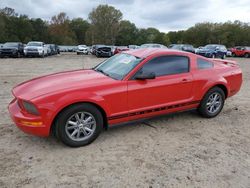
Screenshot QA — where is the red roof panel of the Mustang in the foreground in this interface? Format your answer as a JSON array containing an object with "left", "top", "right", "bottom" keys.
[{"left": 123, "top": 48, "right": 189, "bottom": 58}]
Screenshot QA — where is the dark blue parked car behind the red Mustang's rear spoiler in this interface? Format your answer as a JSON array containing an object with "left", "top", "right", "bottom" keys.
[{"left": 197, "top": 44, "right": 227, "bottom": 59}]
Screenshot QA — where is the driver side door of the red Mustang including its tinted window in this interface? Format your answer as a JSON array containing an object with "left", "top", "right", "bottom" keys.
[{"left": 128, "top": 55, "right": 193, "bottom": 119}]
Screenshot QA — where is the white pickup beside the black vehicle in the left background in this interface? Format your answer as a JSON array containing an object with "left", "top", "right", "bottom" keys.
[{"left": 24, "top": 41, "right": 48, "bottom": 57}]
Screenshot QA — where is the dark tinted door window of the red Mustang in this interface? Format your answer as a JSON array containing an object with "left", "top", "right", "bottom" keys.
[{"left": 137, "top": 56, "right": 189, "bottom": 77}]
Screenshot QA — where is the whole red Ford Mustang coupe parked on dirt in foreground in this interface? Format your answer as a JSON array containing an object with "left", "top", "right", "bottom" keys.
[{"left": 9, "top": 49, "right": 242, "bottom": 147}]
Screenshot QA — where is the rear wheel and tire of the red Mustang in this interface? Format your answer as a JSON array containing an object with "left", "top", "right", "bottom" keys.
[{"left": 198, "top": 87, "right": 225, "bottom": 118}]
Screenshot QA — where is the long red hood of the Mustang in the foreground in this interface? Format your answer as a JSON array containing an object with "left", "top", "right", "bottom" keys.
[{"left": 12, "top": 70, "right": 112, "bottom": 100}]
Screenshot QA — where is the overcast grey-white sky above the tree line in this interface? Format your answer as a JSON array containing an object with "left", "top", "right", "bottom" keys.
[{"left": 0, "top": 0, "right": 250, "bottom": 32}]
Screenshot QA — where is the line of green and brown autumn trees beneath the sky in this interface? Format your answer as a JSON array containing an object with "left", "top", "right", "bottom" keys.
[{"left": 0, "top": 5, "right": 250, "bottom": 47}]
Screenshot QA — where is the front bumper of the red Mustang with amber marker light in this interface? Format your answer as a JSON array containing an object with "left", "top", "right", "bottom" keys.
[{"left": 8, "top": 99, "right": 50, "bottom": 137}]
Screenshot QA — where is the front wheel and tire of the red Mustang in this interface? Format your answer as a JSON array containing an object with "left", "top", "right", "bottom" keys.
[{"left": 56, "top": 104, "right": 103, "bottom": 147}]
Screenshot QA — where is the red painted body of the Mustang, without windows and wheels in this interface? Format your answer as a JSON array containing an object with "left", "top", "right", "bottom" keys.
[{"left": 9, "top": 49, "right": 242, "bottom": 136}]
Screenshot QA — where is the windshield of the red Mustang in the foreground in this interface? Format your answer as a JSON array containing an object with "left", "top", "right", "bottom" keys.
[{"left": 94, "top": 53, "right": 141, "bottom": 80}]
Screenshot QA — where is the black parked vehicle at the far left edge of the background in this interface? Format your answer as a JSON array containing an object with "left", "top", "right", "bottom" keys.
[{"left": 0, "top": 42, "right": 24, "bottom": 57}]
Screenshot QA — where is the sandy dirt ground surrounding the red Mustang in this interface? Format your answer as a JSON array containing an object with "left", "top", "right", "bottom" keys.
[{"left": 0, "top": 54, "right": 250, "bottom": 188}]
